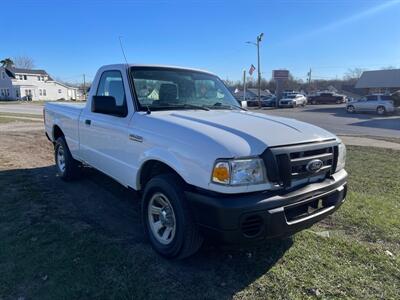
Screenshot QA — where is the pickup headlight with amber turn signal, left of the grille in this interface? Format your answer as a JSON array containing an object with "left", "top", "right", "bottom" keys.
[{"left": 212, "top": 158, "right": 266, "bottom": 185}]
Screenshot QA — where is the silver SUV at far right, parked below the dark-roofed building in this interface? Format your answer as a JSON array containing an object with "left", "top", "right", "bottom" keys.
[{"left": 346, "top": 94, "right": 396, "bottom": 115}]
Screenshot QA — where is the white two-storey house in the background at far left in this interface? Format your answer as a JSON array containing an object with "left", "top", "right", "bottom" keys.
[{"left": 0, "top": 67, "right": 77, "bottom": 100}]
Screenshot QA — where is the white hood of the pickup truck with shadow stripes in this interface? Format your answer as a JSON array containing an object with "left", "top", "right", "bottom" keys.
[{"left": 144, "top": 110, "right": 336, "bottom": 156}]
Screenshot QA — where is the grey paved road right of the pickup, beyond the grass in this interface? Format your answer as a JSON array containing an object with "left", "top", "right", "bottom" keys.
[{"left": 254, "top": 104, "right": 400, "bottom": 138}]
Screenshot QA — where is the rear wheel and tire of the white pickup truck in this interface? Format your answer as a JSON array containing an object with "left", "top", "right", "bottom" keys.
[{"left": 54, "top": 137, "right": 81, "bottom": 181}]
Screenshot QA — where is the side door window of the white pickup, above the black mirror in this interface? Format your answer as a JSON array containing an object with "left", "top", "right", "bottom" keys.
[{"left": 96, "top": 71, "right": 126, "bottom": 109}]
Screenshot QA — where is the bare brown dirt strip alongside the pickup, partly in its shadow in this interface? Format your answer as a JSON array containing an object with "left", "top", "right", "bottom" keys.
[{"left": 0, "top": 123, "right": 143, "bottom": 241}]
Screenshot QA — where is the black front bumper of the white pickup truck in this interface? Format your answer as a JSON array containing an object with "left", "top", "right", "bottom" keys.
[{"left": 186, "top": 170, "right": 347, "bottom": 243}]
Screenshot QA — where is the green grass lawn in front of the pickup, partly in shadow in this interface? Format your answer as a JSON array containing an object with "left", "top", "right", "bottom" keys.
[{"left": 0, "top": 147, "right": 400, "bottom": 299}]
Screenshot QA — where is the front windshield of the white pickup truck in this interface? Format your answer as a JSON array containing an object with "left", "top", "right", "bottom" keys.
[{"left": 131, "top": 67, "right": 240, "bottom": 110}]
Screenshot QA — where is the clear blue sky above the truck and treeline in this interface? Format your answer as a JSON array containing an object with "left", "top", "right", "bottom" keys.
[{"left": 0, "top": 0, "right": 400, "bottom": 82}]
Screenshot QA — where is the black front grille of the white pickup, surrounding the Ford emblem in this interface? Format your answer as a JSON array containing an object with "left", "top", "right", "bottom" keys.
[{"left": 261, "top": 140, "right": 338, "bottom": 187}]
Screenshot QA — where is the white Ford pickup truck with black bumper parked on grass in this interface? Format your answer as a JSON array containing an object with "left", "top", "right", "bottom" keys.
[{"left": 44, "top": 64, "right": 347, "bottom": 258}]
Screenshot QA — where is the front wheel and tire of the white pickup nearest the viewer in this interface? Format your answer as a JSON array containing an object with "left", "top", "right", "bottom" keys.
[{"left": 142, "top": 174, "right": 203, "bottom": 259}]
